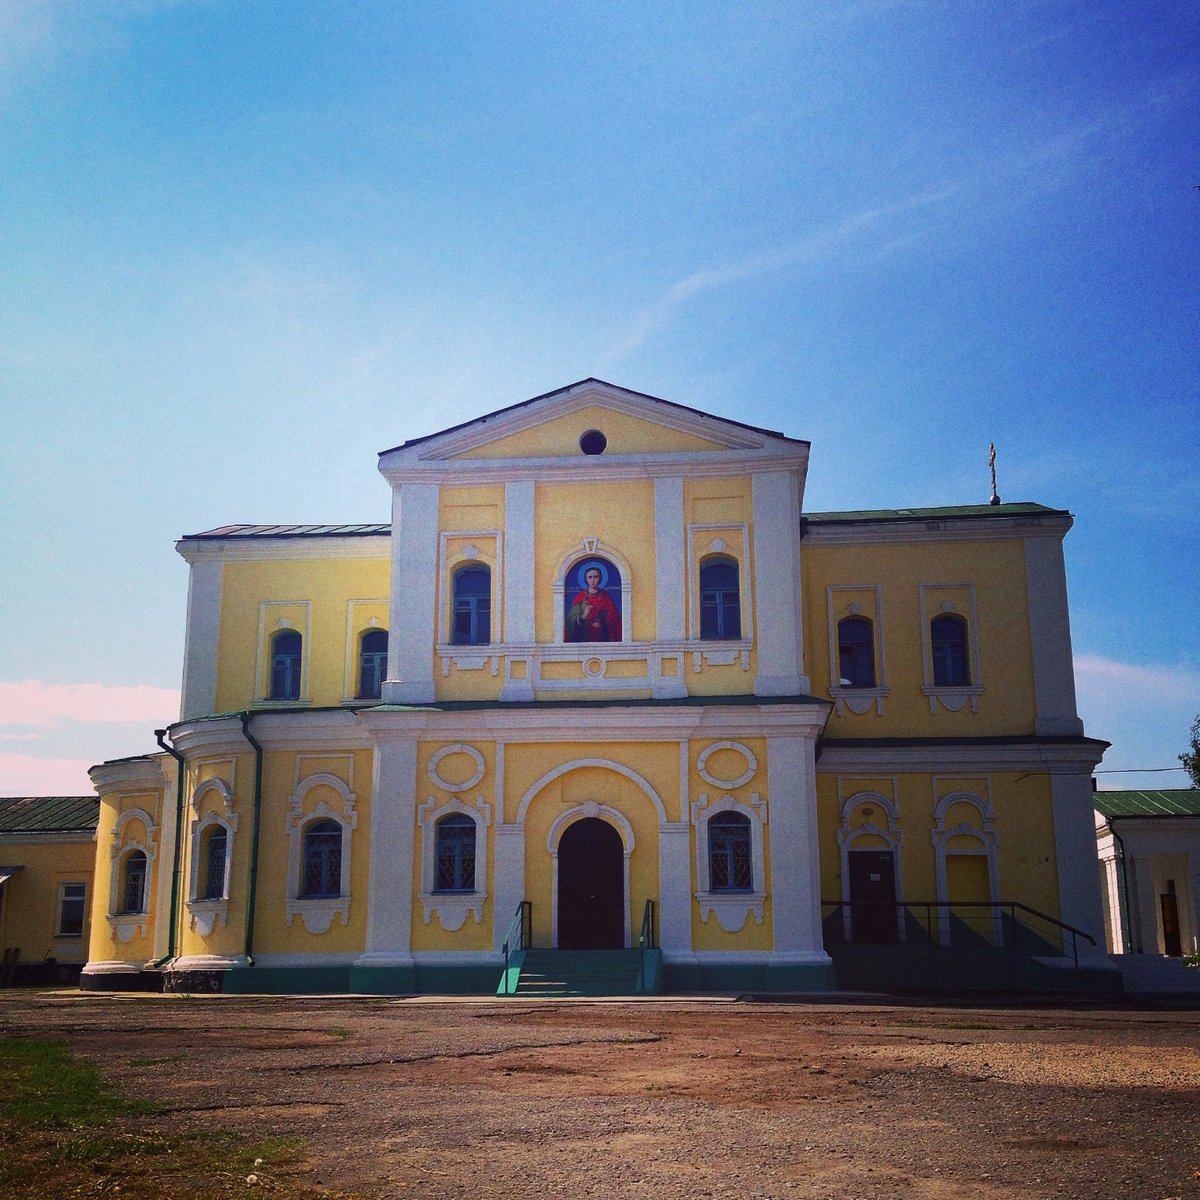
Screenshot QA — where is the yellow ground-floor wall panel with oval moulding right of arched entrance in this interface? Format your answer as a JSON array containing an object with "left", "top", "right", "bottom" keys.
[{"left": 688, "top": 738, "right": 774, "bottom": 950}]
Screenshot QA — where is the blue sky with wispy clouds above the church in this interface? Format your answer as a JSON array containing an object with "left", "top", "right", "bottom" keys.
[{"left": 0, "top": 0, "right": 1200, "bottom": 794}]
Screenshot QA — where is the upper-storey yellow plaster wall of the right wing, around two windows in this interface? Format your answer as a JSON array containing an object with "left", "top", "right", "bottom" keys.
[{"left": 803, "top": 538, "right": 1036, "bottom": 737}]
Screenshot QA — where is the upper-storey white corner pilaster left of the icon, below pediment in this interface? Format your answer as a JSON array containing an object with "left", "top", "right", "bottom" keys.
[{"left": 383, "top": 484, "right": 438, "bottom": 704}]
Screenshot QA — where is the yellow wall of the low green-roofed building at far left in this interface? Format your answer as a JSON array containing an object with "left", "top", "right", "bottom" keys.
[{"left": 0, "top": 834, "right": 96, "bottom": 964}]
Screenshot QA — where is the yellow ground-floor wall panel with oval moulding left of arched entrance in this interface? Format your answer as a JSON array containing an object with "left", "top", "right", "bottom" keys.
[{"left": 412, "top": 742, "right": 497, "bottom": 950}]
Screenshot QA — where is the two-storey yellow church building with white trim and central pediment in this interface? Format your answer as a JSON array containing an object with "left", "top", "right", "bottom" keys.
[{"left": 83, "top": 379, "right": 1116, "bottom": 994}]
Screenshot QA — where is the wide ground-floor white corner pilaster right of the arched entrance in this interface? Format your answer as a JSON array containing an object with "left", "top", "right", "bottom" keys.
[{"left": 767, "top": 737, "right": 830, "bottom": 964}]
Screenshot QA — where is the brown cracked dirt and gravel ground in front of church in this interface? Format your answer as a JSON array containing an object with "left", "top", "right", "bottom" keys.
[{"left": 0, "top": 991, "right": 1200, "bottom": 1200}]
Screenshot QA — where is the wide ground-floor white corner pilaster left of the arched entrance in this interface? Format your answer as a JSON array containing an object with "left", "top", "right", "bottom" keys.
[{"left": 358, "top": 731, "right": 416, "bottom": 966}]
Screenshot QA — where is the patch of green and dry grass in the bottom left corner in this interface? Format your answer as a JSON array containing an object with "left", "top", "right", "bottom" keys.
[{"left": 0, "top": 1039, "right": 312, "bottom": 1200}]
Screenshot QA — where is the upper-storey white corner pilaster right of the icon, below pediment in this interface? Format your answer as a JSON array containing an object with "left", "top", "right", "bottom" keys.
[{"left": 752, "top": 470, "right": 809, "bottom": 696}]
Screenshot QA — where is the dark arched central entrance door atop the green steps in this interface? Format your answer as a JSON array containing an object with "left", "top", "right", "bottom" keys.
[{"left": 558, "top": 817, "right": 625, "bottom": 950}]
